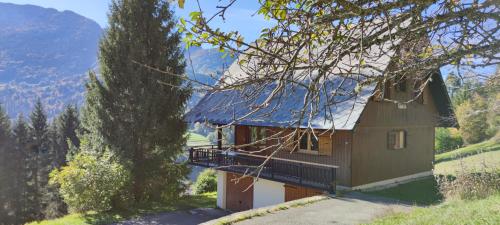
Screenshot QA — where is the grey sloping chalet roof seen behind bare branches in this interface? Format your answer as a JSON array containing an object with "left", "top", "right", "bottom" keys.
[{"left": 186, "top": 18, "right": 408, "bottom": 130}]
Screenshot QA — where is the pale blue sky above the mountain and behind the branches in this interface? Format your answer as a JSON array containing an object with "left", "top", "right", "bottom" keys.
[{"left": 0, "top": 0, "right": 269, "bottom": 41}]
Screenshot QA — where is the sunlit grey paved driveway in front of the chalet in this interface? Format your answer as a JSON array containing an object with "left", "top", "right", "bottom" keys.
[{"left": 236, "top": 193, "right": 411, "bottom": 225}]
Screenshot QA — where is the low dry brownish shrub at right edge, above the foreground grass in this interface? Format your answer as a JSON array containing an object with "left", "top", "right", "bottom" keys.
[{"left": 437, "top": 164, "right": 500, "bottom": 200}]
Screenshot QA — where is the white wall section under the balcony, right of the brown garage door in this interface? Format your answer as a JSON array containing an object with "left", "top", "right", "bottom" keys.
[{"left": 253, "top": 179, "right": 285, "bottom": 209}]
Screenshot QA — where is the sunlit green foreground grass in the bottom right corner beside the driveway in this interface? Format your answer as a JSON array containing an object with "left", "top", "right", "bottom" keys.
[{"left": 372, "top": 195, "right": 500, "bottom": 225}]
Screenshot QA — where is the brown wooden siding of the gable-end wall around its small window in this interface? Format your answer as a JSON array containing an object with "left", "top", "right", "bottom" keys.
[{"left": 352, "top": 85, "right": 438, "bottom": 186}]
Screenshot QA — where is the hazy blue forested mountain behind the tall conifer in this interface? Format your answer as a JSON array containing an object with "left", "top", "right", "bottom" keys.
[{"left": 0, "top": 3, "right": 232, "bottom": 117}]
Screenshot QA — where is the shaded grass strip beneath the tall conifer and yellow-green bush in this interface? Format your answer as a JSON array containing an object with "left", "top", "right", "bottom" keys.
[{"left": 82, "top": 192, "right": 217, "bottom": 225}]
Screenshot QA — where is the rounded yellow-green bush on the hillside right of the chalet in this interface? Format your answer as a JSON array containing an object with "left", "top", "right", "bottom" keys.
[{"left": 455, "top": 95, "right": 488, "bottom": 144}]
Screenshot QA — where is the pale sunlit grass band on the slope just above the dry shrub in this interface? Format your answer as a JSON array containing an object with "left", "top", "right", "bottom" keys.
[{"left": 434, "top": 151, "right": 500, "bottom": 175}]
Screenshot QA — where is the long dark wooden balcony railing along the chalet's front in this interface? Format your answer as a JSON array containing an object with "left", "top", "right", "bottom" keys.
[{"left": 189, "top": 147, "right": 338, "bottom": 192}]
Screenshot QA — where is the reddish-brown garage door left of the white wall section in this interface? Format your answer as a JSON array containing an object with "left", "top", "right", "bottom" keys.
[{"left": 226, "top": 173, "right": 253, "bottom": 211}]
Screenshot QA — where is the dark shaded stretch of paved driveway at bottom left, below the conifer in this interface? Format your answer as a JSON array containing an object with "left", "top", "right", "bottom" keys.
[{"left": 115, "top": 209, "right": 228, "bottom": 225}]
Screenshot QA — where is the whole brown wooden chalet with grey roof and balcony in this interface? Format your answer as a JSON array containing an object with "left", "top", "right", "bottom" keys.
[{"left": 186, "top": 20, "right": 456, "bottom": 211}]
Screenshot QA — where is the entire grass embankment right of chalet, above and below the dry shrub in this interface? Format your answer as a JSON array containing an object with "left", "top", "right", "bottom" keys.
[{"left": 369, "top": 141, "right": 500, "bottom": 225}]
